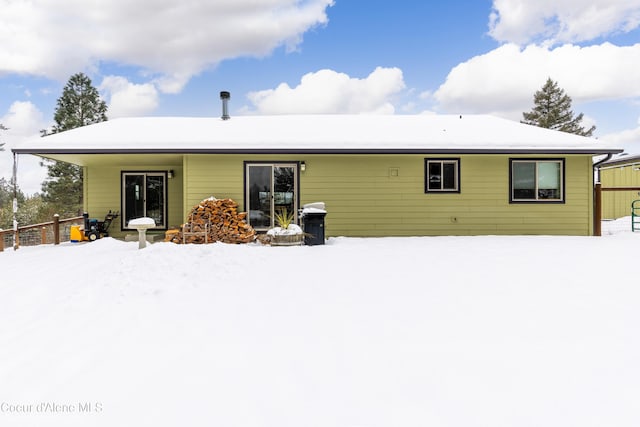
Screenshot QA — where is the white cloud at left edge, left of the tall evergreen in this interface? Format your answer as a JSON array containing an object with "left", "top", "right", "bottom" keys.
[{"left": 0, "top": 101, "right": 47, "bottom": 194}]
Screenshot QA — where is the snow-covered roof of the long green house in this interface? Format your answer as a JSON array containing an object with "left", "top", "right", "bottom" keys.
[{"left": 13, "top": 115, "right": 622, "bottom": 154}]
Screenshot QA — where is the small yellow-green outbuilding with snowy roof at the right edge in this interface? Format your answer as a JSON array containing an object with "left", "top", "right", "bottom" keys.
[{"left": 598, "top": 153, "right": 640, "bottom": 219}]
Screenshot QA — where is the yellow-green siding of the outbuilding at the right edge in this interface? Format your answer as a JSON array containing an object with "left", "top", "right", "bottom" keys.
[{"left": 600, "top": 163, "right": 640, "bottom": 219}]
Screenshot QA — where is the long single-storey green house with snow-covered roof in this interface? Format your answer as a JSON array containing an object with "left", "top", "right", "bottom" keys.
[{"left": 13, "top": 115, "right": 621, "bottom": 236}]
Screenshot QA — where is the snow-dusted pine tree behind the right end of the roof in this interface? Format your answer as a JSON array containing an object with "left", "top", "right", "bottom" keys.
[{"left": 521, "top": 78, "right": 596, "bottom": 136}]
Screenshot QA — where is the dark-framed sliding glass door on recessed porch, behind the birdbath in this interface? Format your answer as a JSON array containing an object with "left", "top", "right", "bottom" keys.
[{"left": 122, "top": 172, "right": 167, "bottom": 229}]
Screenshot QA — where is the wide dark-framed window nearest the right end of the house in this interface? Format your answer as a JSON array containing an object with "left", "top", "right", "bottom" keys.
[{"left": 510, "top": 159, "right": 564, "bottom": 202}]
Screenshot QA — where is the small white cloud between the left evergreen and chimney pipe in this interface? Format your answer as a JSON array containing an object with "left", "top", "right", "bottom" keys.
[{"left": 99, "top": 76, "right": 158, "bottom": 119}]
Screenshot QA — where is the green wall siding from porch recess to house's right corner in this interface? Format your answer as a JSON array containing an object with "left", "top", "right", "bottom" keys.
[{"left": 184, "top": 155, "right": 593, "bottom": 236}]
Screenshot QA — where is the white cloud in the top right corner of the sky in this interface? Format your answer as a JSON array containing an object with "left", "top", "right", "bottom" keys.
[{"left": 489, "top": 0, "right": 640, "bottom": 45}]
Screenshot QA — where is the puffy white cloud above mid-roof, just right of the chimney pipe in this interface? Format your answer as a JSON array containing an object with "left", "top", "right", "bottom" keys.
[{"left": 248, "top": 67, "right": 405, "bottom": 114}]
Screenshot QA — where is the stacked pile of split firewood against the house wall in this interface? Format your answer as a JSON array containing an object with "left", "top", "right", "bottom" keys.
[{"left": 165, "top": 197, "right": 256, "bottom": 243}]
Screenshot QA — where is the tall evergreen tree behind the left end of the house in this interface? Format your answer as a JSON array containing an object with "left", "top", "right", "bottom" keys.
[{"left": 42, "top": 73, "right": 107, "bottom": 218}]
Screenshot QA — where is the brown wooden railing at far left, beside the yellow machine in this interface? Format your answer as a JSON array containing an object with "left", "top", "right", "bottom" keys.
[{"left": 0, "top": 214, "right": 84, "bottom": 252}]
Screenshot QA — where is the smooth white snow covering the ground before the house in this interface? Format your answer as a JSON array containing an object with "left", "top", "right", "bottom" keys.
[{"left": 0, "top": 218, "right": 640, "bottom": 427}]
